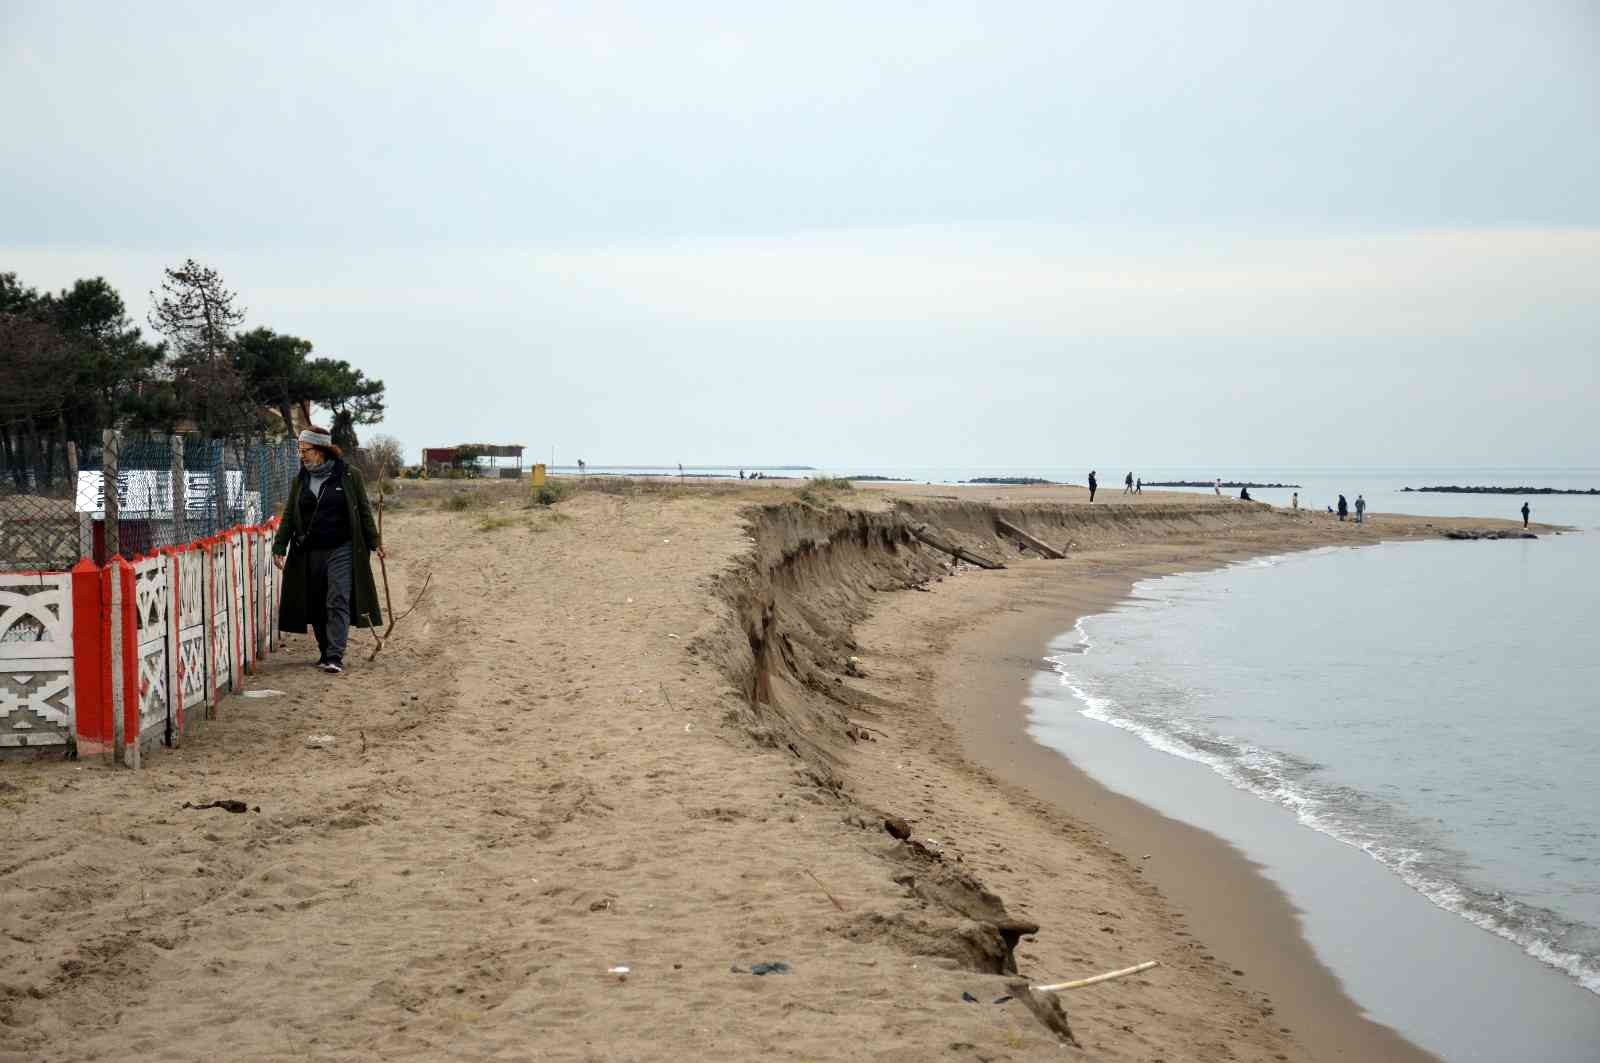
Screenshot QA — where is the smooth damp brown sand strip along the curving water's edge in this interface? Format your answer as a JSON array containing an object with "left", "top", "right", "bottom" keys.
[{"left": 851, "top": 536, "right": 1438, "bottom": 1063}]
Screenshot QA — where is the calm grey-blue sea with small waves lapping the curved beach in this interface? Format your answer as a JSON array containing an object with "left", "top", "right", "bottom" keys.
[{"left": 566, "top": 466, "right": 1600, "bottom": 1063}]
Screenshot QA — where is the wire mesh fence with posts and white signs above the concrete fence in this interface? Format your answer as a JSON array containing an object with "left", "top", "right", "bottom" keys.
[{"left": 0, "top": 432, "right": 299, "bottom": 572}]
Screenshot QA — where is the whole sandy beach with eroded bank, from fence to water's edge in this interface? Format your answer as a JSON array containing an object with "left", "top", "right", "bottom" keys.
[{"left": 0, "top": 483, "right": 1536, "bottom": 1060}]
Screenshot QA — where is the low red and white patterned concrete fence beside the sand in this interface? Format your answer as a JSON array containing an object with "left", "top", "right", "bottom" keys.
[{"left": 0, "top": 519, "right": 282, "bottom": 767}]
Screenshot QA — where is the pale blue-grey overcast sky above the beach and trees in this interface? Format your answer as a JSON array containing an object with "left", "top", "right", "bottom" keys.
[{"left": 0, "top": 0, "right": 1600, "bottom": 472}]
